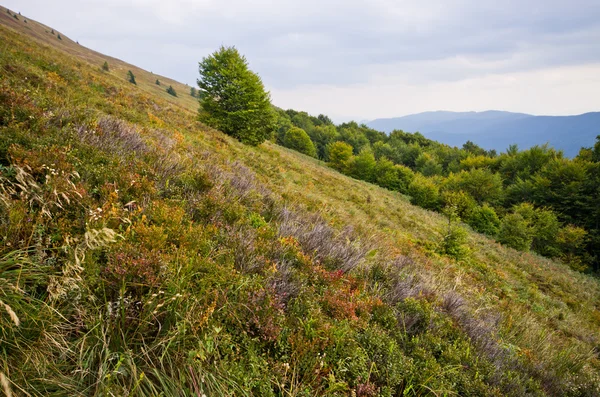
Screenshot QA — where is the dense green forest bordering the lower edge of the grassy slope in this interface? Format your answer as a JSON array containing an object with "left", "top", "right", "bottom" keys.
[{"left": 273, "top": 109, "right": 600, "bottom": 273}]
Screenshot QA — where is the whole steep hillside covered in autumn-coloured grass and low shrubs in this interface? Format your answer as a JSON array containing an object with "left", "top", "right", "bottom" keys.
[{"left": 0, "top": 9, "right": 600, "bottom": 396}]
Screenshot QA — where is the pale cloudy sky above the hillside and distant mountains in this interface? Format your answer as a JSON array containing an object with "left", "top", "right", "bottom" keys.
[{"left": 3, "top": 0, "right": 600, "bottom": 121}]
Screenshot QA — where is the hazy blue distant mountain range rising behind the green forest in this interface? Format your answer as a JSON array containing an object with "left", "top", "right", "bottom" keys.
[{"left": 367, "top": 110, "right": 600, "bottom": 157}]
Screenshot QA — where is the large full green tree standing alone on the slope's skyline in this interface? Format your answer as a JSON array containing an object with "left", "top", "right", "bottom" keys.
[{"left": 198, "top": 47, "right": 275, "bottom": 146}]
